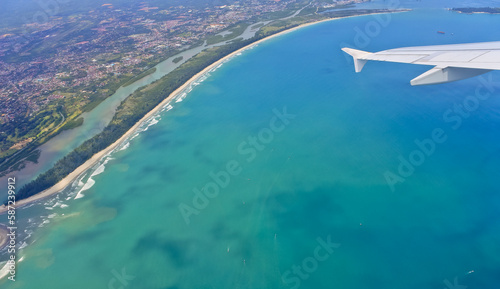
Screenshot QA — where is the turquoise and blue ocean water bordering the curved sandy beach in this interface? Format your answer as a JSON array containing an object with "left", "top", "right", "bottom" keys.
[{"left": 0, "top": 8, "right": 500, "bottom": 289}]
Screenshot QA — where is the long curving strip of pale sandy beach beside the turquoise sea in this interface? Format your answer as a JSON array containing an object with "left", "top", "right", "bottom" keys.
[{"left": 0, "top": 10, "right": 402, "bottom": 215}]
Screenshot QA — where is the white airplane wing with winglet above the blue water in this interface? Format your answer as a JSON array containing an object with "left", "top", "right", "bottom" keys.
[{"left": 342, "top": 41, "right": 500, "bottom": 85}]
